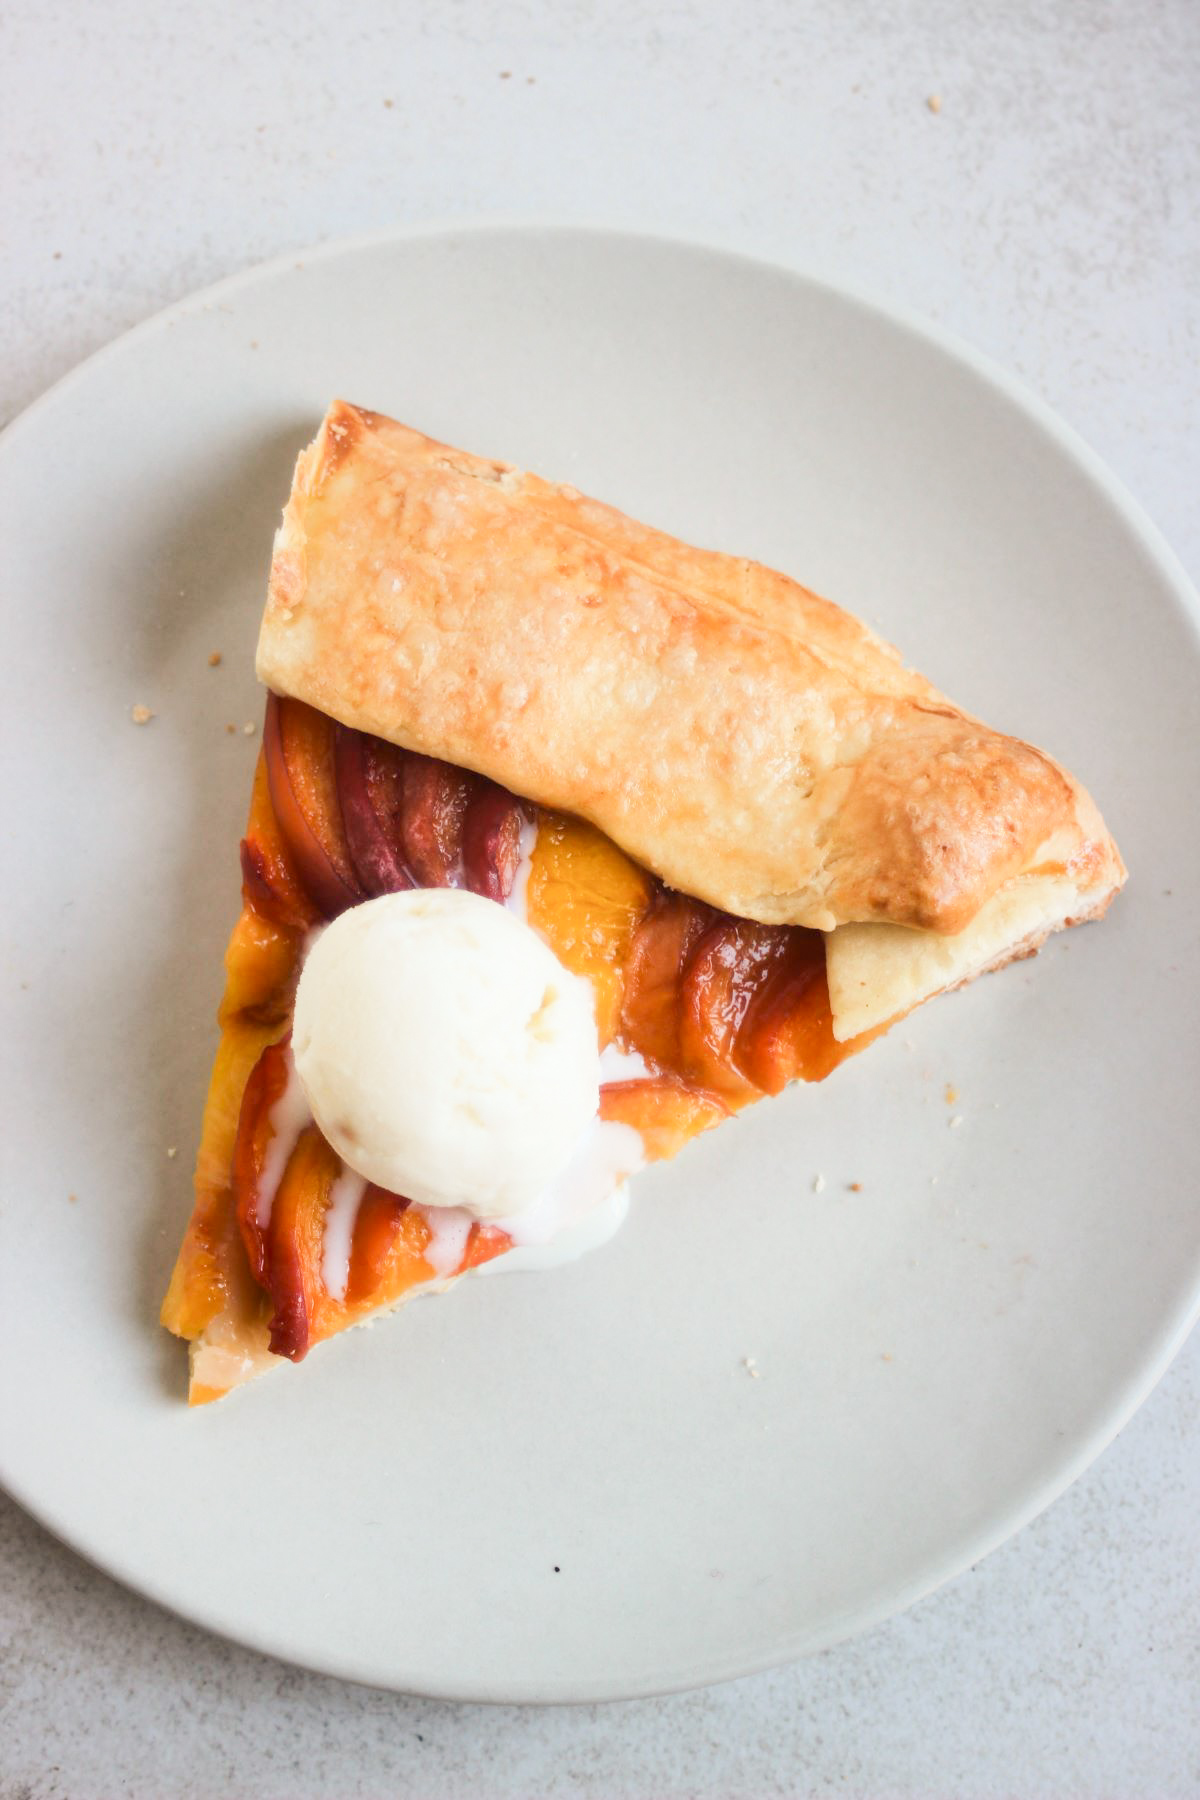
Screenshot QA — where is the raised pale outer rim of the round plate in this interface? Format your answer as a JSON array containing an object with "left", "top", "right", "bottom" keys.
[{"left": 0, "top": 212, "right": 1200, "bottom": 1705}]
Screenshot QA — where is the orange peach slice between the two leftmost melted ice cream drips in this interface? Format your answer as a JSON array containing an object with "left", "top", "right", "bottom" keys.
[{"left": 266, "top": 1125, "right": 342, "bottom": 1363}]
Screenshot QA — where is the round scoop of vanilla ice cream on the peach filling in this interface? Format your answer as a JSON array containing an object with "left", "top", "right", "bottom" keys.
[{"left": 291, "top": 887, "right": 599, "bottom": 1219}]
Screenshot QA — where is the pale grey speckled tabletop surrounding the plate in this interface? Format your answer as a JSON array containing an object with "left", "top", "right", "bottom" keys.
[{"left": 0, "top": 0, "right": 1200, "bottom": 1800}]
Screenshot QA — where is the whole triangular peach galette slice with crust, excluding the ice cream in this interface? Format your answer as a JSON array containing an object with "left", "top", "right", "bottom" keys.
[{"left": 162, "top": 401, "right": 1124, "bottom": 1404}]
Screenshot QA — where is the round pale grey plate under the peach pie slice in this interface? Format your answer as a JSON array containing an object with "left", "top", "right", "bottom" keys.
[{"left": 0, "top": 229, "right": 1200, "bottom": 1699}]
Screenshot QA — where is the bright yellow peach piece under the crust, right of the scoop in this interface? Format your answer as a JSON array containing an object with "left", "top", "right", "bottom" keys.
[{"left": 527, "top": 812, "right": 653, "bottom": 1048}]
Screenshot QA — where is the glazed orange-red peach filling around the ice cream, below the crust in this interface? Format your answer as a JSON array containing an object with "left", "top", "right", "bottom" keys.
[{"left": 162, "top": 695, "right": 873, "bottom": 1404}]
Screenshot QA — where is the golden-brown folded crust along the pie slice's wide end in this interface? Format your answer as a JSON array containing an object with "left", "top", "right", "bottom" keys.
[{"left": 257, "top": 401, "right": 1124, "bottom": 934}]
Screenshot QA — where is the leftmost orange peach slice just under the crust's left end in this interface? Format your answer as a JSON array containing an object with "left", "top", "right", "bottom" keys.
[{"left": 263, "top": 693, "right": 363, "bottom": 918}]
